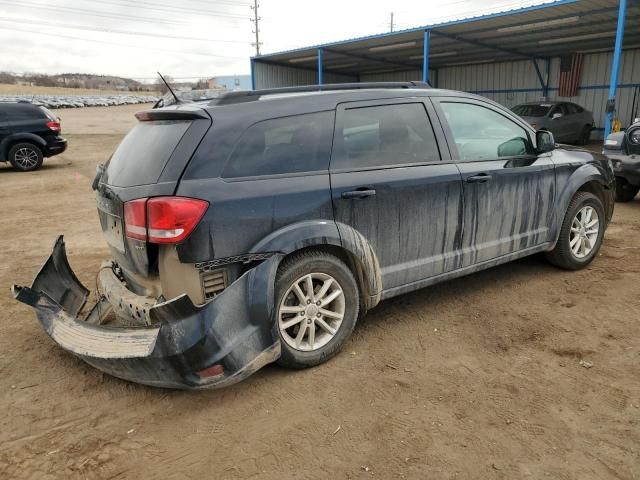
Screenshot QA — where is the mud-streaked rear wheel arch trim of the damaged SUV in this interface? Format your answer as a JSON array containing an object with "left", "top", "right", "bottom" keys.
[{"left": 250, "top": 220, "right": 382, "bottom": 313}]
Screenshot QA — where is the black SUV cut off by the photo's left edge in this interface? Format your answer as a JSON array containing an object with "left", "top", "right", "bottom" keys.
[{"left": 0, "top": 102, "right": 67, "bottom": 172}]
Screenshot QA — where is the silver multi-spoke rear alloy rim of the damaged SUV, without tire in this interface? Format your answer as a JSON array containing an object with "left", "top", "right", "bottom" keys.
[{"left": 278, "top": 273, "right": 345, "bottom": 352}]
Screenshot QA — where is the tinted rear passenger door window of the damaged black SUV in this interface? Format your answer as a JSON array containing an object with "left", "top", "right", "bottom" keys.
[{"left": 331, "top": 102, "right": 440, "bottom": 170}]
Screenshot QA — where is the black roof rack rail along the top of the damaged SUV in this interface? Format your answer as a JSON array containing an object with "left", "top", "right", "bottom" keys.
[{"left": 214, "top": 82, "right": 431, "bottom": 105}]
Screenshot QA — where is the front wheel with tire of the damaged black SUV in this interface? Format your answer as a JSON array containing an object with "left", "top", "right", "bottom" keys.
[{"left": 547, "top": 192, "right": 606, "bottom": 270}]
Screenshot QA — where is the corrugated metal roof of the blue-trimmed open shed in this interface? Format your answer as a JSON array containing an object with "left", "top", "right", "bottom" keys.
[{"left": 255, "top": 0, "right": 640, "bottom": 75}]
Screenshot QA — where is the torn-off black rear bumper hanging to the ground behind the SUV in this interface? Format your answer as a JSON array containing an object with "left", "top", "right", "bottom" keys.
[{"left": 11, "top": 236, "right": 280, "bottom": 389}]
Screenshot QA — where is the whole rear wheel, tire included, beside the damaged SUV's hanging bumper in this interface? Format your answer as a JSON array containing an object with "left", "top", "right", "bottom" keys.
[{"left": 275, "top": 251, "right": 360, "bottom": 368}]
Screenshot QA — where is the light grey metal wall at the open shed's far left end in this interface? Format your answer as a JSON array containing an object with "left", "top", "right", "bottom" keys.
[{"left": 254, "top": 62, "right": 358, "bottom": 88}]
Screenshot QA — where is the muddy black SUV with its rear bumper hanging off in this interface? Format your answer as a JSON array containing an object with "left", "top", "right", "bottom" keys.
[{"left": 13, "top": 84, "right": 615, "bottom": 388}]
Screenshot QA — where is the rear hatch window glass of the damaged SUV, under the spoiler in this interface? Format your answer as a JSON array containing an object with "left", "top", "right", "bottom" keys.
[{"left": 105, "top": 120, "right": 191, "bottom": 187}]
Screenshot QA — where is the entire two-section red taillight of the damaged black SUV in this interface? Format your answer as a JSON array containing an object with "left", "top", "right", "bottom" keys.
[{"left": 124, "top": 197, "right": 209, "bottom": 243}]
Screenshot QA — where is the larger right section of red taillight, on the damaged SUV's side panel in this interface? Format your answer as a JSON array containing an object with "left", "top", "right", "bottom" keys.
[{"left": 147, "top": 197, "right": 209, "bottom": 243}]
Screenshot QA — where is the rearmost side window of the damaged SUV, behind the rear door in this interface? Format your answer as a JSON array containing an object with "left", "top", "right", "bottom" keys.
[{"left": 222, "top": 112, "right": 334, "bottom": 178}]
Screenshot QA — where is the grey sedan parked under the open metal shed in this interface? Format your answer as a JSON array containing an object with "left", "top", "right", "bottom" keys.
[{"left": 511, "top": 102, "right": 594, "bottom": 145}]
